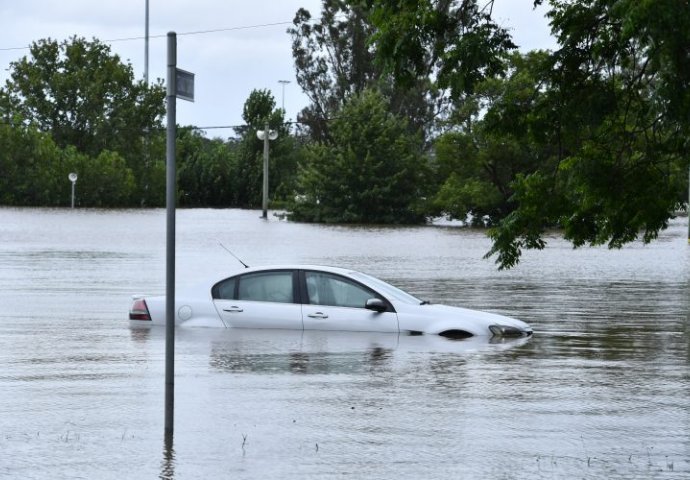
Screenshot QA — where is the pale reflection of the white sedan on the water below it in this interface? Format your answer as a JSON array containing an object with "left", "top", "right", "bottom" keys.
[{"left": 130, "top": 327, "right": 532, "bottom": 375}]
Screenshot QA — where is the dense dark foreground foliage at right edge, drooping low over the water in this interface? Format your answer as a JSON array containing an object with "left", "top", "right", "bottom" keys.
[{"left": 490, "top": 0, "right": 690, "bottom": 267}]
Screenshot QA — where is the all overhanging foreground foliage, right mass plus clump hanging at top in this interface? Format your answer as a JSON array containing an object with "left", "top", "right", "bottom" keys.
[{"left": 364, "top": 0, "right": 690, "bottom": 268}]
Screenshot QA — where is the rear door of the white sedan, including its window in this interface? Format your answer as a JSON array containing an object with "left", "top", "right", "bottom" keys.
[{"left": 212, "top": 270, "right": 303, "bottom": 330}]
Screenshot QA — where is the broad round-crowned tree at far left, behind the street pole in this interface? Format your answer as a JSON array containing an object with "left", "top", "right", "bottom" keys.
[{"left": 0, "top": 37, "right": 165, "bottom": 204}]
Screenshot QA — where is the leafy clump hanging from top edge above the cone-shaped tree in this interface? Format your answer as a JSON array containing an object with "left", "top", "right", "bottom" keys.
[{"left": 362, "top": 0, "right": 516, "bottom": 99}]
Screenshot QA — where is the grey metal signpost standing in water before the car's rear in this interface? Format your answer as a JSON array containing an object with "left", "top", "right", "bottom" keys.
[{"left": 165, "top": 32, "right": 177, "bottom": 439}]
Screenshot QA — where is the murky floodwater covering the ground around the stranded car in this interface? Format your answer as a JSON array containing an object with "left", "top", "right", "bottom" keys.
[{"left": 0, "top": 208, "right": 690, "bottom": 480}]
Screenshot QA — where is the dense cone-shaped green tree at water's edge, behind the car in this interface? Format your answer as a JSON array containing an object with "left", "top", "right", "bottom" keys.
[{"left": 290, "top": 90, "right": 427, "bottom": 223}]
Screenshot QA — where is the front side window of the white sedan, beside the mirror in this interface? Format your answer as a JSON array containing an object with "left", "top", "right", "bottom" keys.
[{"left": 304, "top": 272, "right": 379, "bottom": 308}]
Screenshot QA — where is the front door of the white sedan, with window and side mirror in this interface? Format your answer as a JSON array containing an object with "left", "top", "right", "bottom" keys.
[{"left": 301, "top": 270, "right": 399, "bottom": 332}]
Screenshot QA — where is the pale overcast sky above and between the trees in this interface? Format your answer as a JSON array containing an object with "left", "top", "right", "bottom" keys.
[{"left": 0, "top": 0, "right": 554, "bottom": 137}]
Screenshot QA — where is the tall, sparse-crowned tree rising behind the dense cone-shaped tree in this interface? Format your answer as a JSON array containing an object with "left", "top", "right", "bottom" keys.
[{"left": 288, "top": 0, "right": 435, "bottom": 141}]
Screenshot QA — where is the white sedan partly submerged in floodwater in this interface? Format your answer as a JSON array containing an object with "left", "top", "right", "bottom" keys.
[{"left": 129, "top": 265, "right": 532, "bottom": 338}]
